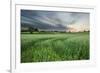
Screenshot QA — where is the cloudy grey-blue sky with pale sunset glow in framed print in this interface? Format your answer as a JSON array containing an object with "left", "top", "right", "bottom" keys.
[{"left": 21, "top": 10, "right": 90, "bottom": 32}]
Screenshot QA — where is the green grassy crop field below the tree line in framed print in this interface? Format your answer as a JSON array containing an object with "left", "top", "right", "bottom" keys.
[{"left": 21, "top": 32, "right": 89, "bottom": 63}]
